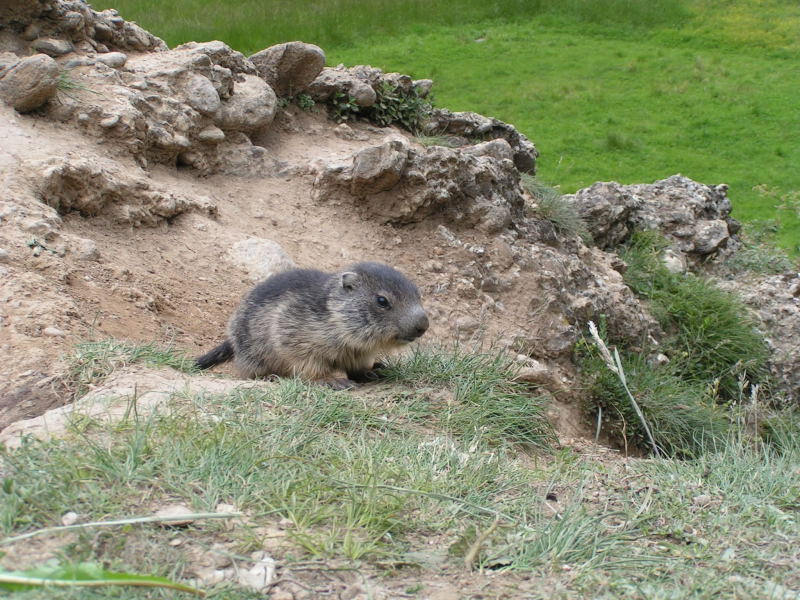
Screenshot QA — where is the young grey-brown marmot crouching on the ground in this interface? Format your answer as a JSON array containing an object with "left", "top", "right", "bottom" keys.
[{"left": 196, "top": 262, "right": 428, "bottom": 383}]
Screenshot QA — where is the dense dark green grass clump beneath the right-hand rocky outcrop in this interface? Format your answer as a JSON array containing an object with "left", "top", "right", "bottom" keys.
[{"left": 579, "top": 231, "right": 768, "bottom": 456}]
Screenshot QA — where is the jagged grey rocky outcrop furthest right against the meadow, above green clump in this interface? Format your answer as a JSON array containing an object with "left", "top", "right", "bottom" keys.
[{"left": 564, "top": 175, "right": 740, "bottom": 262}]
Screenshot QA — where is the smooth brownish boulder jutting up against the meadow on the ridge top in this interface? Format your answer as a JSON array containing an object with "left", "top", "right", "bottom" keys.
[{"left": 250, "top": 42, "right": 325, "bottom": 97}]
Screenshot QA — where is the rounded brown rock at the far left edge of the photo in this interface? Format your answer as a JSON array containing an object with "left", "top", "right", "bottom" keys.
[{"left": 0, "top": 54, "right": 58, "bottom": 113}]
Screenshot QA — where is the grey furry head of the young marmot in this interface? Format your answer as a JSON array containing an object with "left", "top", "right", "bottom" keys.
[{"left": 334, "top": 262, "right": 428, "bottom": 346}]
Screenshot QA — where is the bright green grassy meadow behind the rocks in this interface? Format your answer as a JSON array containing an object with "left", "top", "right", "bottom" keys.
[{"left": 94, "top": 0, "right": 800, "bottom": 256}]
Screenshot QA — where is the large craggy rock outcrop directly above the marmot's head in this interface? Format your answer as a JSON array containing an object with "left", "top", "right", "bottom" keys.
[{"left": 314, "top": 137, "right": 524, "bottom": 233}]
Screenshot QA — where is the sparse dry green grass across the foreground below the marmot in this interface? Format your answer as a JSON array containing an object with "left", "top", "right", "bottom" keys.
[{"left": 0, "top": 351, "right": 800, "bottom": 598}]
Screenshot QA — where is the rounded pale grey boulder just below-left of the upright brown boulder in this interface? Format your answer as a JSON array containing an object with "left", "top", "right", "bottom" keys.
[{"left": 215, "top": 75, "right": 278, "bottom": 133}]
